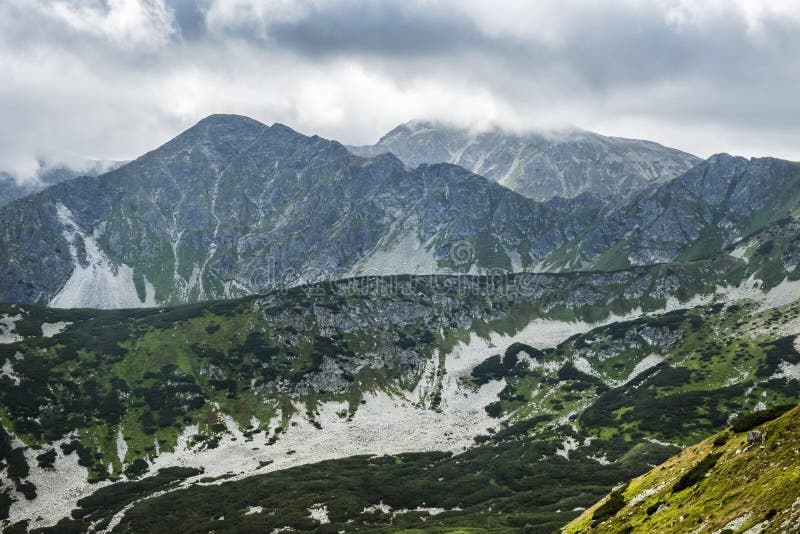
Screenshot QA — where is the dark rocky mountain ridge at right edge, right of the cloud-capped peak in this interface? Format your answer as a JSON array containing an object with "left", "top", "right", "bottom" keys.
[{"left": 556, "top": 154, "right": 800, "bottom": 268}]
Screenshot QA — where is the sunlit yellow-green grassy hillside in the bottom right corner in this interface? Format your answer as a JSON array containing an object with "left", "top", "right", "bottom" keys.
[{"left": 563, "top": 407, "right": 800, "bottom": 534}]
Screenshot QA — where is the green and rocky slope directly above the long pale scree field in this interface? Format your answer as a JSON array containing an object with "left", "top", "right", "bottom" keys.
[{"left": 0, "top": 266, "right": 752, "bottom": 488}]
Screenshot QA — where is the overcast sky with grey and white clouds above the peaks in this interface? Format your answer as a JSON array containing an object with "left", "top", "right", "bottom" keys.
[{"left": 0, "top": 0, "right": 800, "bottom": 181}]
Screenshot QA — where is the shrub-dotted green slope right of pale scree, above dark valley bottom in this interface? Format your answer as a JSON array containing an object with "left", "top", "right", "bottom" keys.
[{"left": 488, "top": 304, "right": 800, "bottom": 445}]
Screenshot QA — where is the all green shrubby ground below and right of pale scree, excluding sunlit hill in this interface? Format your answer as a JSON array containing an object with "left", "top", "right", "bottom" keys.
[{"left": 21, "top": 300, "right": 800, "bottom": 532}]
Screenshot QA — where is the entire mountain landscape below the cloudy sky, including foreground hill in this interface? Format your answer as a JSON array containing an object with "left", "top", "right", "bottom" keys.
[{"left": 0, "top": 115, "right": 800, "bottom": 533}]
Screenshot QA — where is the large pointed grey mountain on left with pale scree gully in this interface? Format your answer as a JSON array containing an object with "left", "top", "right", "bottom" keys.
[{"left": 0, "top": 115, "right": 603, "bottom": 307}]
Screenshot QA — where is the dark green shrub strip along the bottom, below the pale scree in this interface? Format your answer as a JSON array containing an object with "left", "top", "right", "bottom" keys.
[{"left": 45, "top": 429, "right": 675, "bottom": 533}]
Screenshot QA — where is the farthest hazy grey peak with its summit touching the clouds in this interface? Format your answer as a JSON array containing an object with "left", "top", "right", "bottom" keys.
[{"left": 350, "top": 120, "right": 701, "bottom": 200}]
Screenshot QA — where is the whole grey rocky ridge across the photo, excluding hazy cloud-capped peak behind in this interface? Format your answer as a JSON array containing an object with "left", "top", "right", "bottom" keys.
[{"left": 0, "top": 115, "right": 800, "bottom": 308}]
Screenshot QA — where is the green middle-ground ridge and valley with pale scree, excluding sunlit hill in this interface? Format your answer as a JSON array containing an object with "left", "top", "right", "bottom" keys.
[{"left": 0, "top": 217, "right": 800, "bottom": 532}]
